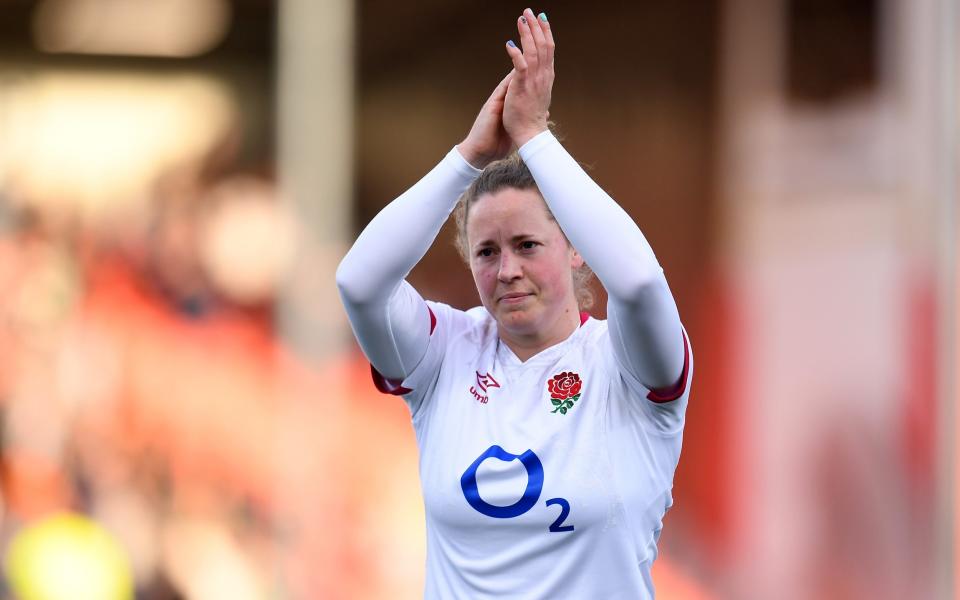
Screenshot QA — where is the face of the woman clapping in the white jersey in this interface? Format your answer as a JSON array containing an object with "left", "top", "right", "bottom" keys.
[{"left": 467, "top": 188, "right": 583, "bottom": 338}]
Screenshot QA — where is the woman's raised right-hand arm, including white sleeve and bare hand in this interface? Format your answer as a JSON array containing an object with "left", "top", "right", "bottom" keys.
[{"left": 503, "top": 9, "right": 685, "bottom": 390}]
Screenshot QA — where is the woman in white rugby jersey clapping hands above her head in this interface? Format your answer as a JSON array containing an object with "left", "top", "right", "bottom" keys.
[{"left": 337, "top": 9, "right": 692, "bottom": 599}]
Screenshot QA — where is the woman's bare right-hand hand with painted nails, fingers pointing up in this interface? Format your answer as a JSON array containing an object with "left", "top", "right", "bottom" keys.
[{"left": 503, "top": 8, "right": 554, "bottom": 147}]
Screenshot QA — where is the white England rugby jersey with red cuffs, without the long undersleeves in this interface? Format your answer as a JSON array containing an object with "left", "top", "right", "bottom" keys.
[{"left": 374, "top": 302, "right": 693, "bottom": 600}]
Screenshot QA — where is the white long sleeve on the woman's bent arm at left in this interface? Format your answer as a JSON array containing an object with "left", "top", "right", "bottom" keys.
[{"left": 337, "top": 148, "right": 480, "bottom": 380}]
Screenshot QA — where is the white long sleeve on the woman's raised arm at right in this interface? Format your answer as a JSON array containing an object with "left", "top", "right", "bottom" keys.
[{"left": 520, "top": 131, "right": 685, "bottom": 389}]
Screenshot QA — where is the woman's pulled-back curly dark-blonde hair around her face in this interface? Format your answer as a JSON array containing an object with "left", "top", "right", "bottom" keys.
[{"left": 453, "top": 152, "right": 594, "bottom": 310}]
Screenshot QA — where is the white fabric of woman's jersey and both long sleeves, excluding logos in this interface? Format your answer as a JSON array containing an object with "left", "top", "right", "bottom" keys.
[{"left": 337, "top": 132, "right": 692, "bottom": 598}]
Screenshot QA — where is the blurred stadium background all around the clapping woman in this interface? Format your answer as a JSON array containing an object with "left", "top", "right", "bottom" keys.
[{"left": 0, "top": 0, "right": 960, "bottom": 600}]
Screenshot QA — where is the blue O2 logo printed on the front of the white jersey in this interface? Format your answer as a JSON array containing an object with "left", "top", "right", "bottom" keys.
[{"left": 460, "top": 445, "right": 573, "bottom": 533}]
